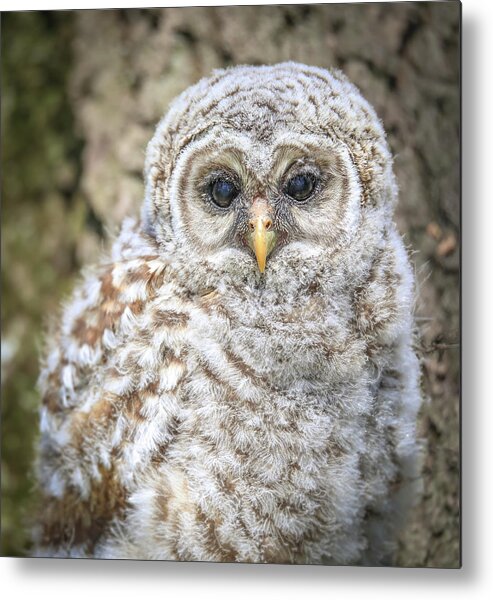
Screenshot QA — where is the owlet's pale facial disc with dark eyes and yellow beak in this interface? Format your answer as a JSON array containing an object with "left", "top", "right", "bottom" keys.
[{"left": 170, "top": 126, "right": 360, "bottom": 273}]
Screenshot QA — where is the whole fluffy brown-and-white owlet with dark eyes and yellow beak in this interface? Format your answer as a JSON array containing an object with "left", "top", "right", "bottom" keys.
[{"left": 34, "top": 63, "right": 420, "bottom": 564}]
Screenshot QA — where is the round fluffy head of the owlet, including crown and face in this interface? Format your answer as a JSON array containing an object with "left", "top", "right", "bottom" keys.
[{"left": 142, "top": 62, "right": 396, "bottom": 290}]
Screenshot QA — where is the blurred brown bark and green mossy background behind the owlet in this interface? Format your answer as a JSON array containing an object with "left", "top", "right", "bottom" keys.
[{"left": 1, "top": 2, "right": 460, "bottom": 567}]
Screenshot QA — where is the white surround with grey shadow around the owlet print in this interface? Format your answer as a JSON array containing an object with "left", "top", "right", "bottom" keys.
[{"left": 0, "top": 0, "right": 493, "bottom": 600}]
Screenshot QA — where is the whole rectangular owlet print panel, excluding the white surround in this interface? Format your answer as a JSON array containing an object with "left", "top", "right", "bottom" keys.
[{"left": 0, "top": 0, "right": 462, "bottom": 571}]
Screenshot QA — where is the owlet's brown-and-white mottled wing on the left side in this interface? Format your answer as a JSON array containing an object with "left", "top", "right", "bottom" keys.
[{"left": 34, "top": 224, "right": 186, "bottom": 557}]
